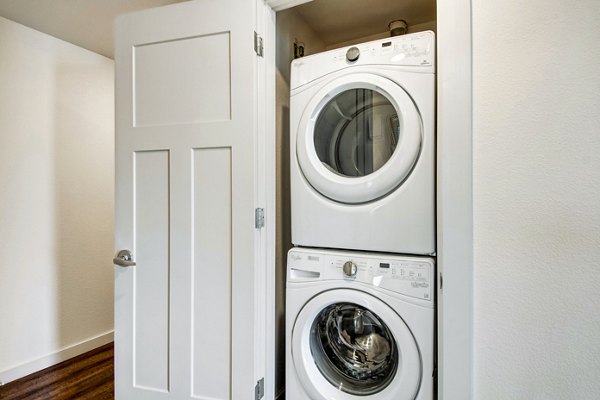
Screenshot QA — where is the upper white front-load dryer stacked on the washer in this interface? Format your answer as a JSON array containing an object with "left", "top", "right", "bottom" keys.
[{"left": 290, "top": 32, "right": 435, "bottom": 255}]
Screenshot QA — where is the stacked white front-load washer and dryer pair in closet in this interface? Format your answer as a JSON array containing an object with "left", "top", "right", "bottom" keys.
[{"left": 286, "top": 32, "right": 435, "bottom": 400}]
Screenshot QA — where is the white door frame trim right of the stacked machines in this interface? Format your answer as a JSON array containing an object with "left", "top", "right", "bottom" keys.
[{"left": 266, "top": 0, "right": 474, "bottom": 400}]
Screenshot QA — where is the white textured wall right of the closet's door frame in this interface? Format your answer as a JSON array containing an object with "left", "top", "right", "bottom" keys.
[{"left": 474, "top": 0, "right": 600, "bottom": 400}]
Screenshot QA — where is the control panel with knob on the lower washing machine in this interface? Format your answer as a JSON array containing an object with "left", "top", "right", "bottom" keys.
[{"left": 287, "top": 248, "right": 435, "bottom": 300}]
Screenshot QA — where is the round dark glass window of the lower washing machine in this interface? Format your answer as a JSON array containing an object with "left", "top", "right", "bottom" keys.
[{"left": 310, "top": 303, "right": 399, "bottom": 396}]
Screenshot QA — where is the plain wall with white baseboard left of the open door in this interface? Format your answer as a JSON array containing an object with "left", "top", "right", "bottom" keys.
[{"left": 0, "top": 18, "right": 114, "bottom": 382}]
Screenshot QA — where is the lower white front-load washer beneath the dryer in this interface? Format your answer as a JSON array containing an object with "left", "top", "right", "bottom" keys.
[{"left": 286, "top": 248, "right": 435, "bottom": 400}]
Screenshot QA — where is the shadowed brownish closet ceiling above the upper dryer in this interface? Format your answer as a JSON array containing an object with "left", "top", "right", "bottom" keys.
[{"left": 295, "top": 0, "right": 436, "bottom": 45}]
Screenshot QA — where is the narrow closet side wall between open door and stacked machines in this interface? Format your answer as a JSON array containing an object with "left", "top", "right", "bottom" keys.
[{"left": 275, "top": 8, "right": 325, "bottom": 393}]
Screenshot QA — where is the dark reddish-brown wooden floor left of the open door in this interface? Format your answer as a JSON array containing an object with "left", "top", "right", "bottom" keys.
[{"left": 0, "top": 343, "right": 115, "bottom": 400}]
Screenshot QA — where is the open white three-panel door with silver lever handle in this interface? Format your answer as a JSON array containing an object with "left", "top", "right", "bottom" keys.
[{"left": 115, "top": 0, "right": 269, "bottom": 400}]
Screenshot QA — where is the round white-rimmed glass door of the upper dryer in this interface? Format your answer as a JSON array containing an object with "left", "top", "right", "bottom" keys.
[{"left": 296, "top": 73, "right": 423, "bottom": 204}]
